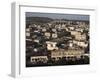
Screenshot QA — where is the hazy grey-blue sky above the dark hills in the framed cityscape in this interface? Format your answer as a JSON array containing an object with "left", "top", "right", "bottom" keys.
[{"left": 26, "top": 12, "right": 89, "bottom": 21}]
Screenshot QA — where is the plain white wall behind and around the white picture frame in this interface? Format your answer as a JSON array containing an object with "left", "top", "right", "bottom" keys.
[{"left": 0, "top": 0, "right": 100, "bottom": 80}]
